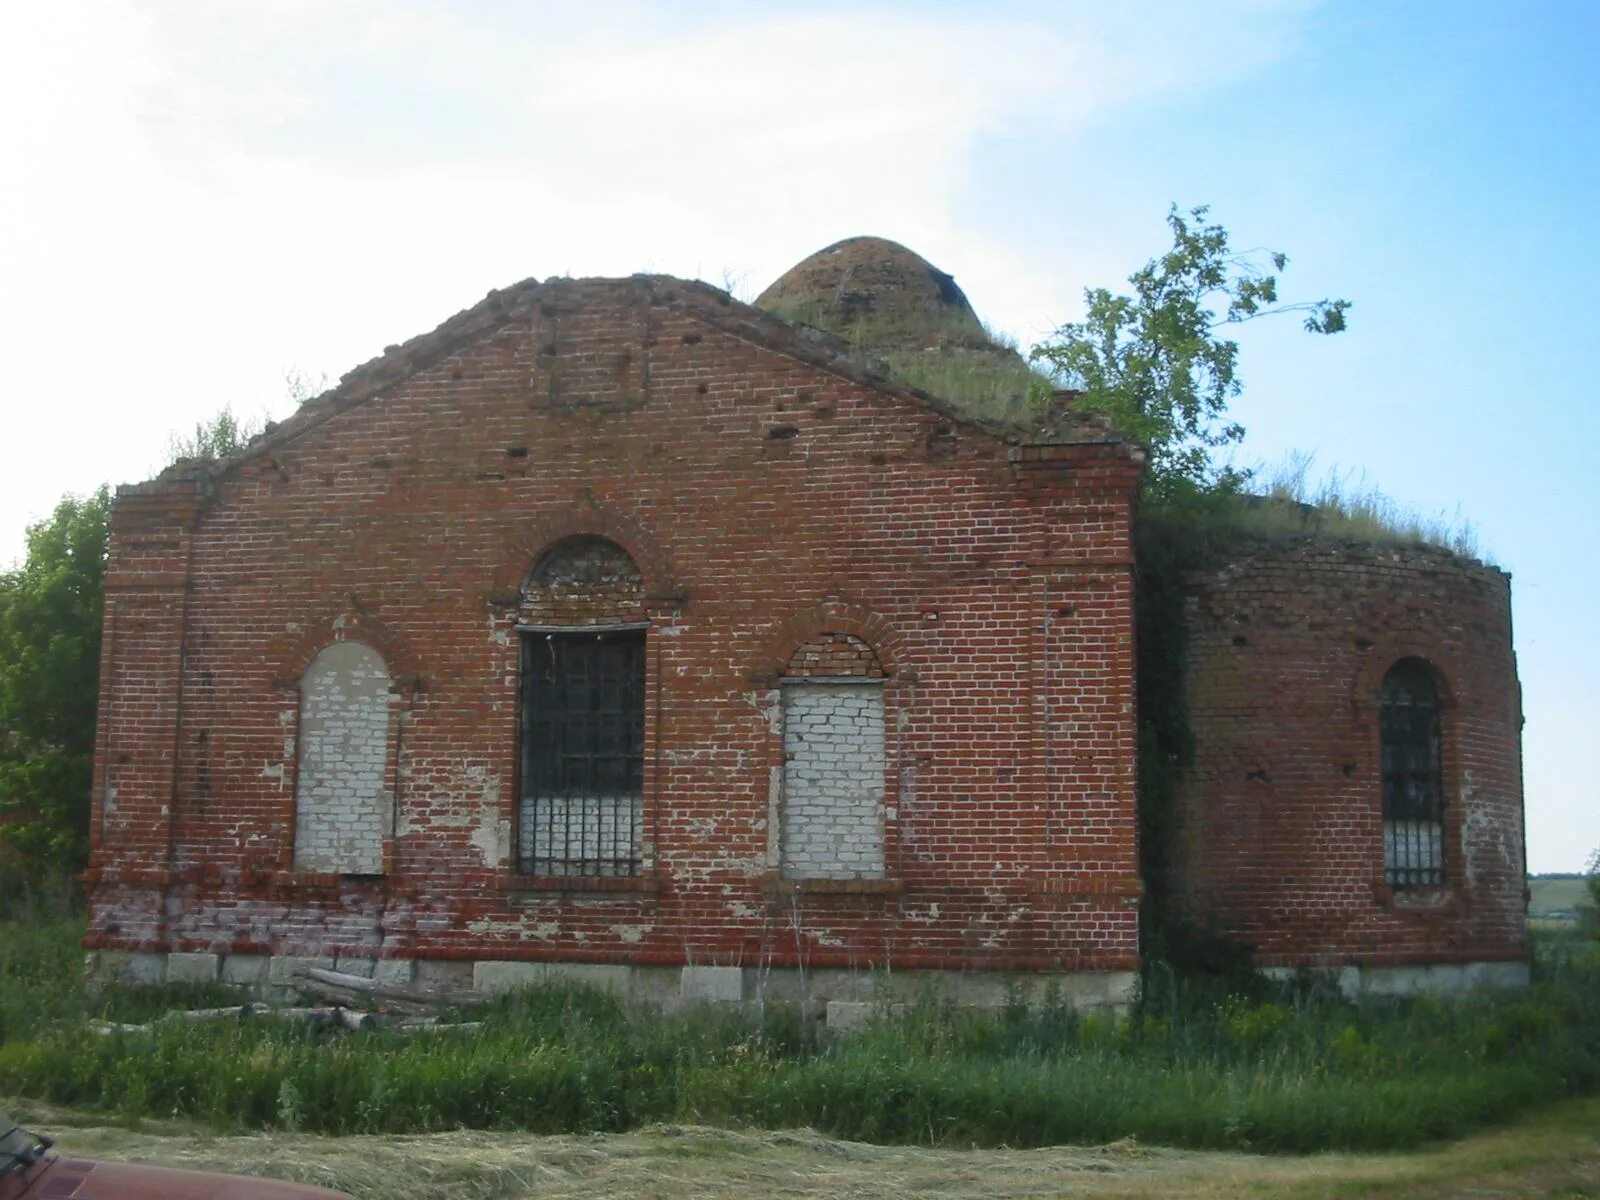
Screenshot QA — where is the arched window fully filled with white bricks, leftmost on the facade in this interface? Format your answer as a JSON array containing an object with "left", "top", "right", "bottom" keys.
[{"left": 294, "top": 642, "right": 390, "bottom": 875}]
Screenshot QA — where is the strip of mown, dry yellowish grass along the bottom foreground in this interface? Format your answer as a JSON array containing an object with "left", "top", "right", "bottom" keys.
[{"left": 0, "top": 1099, "right": 1600, "bottom": 1200}]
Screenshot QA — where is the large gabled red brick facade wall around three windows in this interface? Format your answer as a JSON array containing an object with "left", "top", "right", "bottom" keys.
[{"left": 88, "top": 280, "right": 1139, "bottom": 970}]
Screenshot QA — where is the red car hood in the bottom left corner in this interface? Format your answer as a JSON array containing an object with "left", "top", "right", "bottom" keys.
[{"left": 0, "top": 1155, "right": 350, "bottom": 1200}]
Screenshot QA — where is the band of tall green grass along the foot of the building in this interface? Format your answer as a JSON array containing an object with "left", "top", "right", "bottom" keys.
[{"left": 0, "top": 925, "right": 1600, "bottom": 1150}]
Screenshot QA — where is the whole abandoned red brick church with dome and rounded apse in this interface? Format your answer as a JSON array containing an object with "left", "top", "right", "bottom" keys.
[{"left": 86, "top": 238, "right": 1526, "bottom": 1006}]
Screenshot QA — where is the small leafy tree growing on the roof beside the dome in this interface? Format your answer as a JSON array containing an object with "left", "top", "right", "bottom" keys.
[{"left": 1032, "top": 205, "right": 1350, "bottom": 498}]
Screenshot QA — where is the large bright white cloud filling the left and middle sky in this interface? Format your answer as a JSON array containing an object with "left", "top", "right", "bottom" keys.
[{"left": 0, "top": 0, "right": 1301, "bottom": 560}]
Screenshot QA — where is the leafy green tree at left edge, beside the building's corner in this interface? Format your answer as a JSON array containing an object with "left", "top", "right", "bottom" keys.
[{"left": 0, "top": 488, "right": 107, "bottom": 878}]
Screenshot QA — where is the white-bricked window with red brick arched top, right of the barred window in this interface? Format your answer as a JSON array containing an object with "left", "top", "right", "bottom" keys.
[{"left": 781, "top": 634, "right": 885, "bottom": 880}]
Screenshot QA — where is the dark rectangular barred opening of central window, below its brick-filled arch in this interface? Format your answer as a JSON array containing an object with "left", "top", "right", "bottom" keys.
[{"left": 518, "top": 629, "right": 645, "bottom": 875}]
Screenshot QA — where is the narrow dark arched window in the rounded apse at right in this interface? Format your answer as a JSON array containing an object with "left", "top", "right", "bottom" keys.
[{"left": 1378, "top": 658, "right": 1445, "bottom": 888}]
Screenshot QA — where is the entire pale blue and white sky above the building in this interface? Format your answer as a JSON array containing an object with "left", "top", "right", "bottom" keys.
[{"left": 0, "top": 0, "right": 1600, "bottom": 870}]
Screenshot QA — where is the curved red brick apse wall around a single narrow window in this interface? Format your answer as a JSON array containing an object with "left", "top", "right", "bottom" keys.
[{"left": 1173, "top": 542, "right": 1525, "bottom": 965}]
